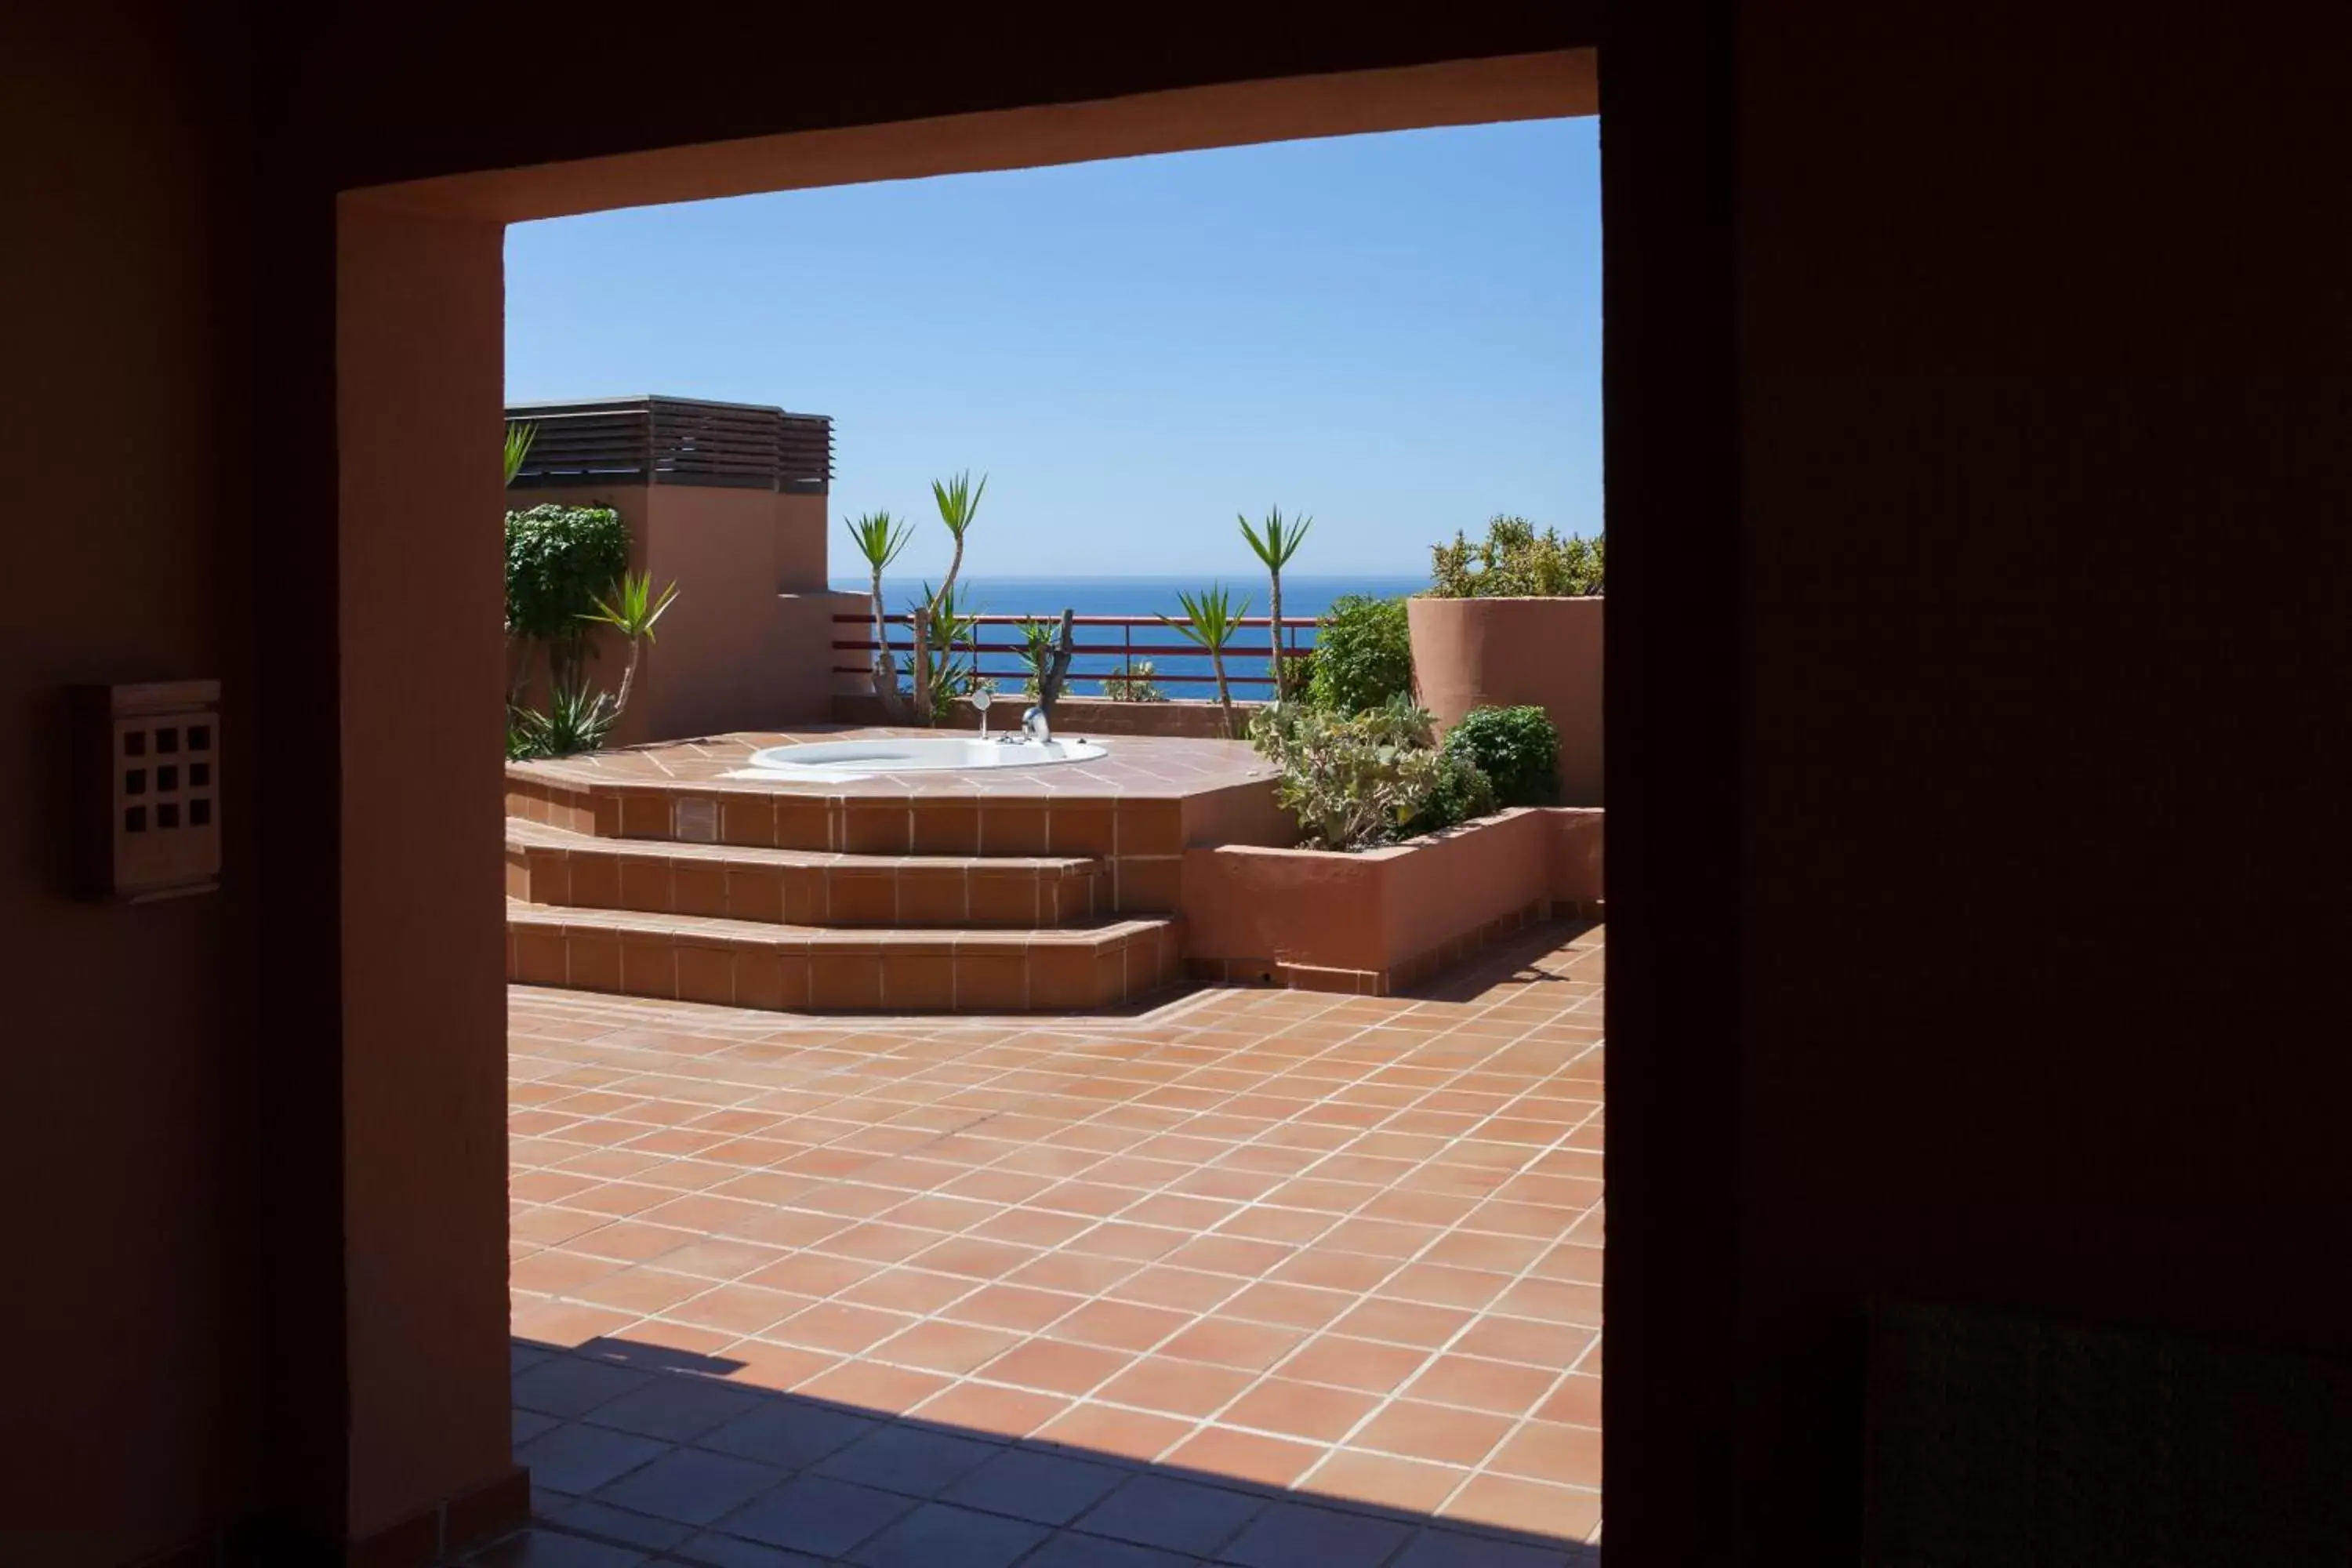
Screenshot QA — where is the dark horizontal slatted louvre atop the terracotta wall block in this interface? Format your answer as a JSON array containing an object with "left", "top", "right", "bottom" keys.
[{"left": 506, "top": 397, "right": 833, "bottom": 494}]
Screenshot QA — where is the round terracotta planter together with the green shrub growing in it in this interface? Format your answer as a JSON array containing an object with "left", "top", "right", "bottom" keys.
[{"left": 1406, "top": 517, "right": 1606, "bottom": 806}]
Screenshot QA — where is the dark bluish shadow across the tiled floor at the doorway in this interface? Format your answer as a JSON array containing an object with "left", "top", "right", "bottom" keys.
[{"left": 487, "top": 1340, "right": 1599, "bottom": 1568}]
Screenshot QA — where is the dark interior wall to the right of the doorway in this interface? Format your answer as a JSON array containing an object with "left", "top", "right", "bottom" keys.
[{"left": 1731, "top": 2, "right": 2352, "bottom": 1561}]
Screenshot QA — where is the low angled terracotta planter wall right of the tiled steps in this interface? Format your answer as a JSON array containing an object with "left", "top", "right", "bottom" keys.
[{"left": 1181, "top": 806, "right": 1602, "bottom": 996}]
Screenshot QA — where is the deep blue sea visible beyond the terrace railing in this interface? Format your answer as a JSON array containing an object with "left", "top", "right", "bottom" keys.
[{"left": 833, "top": 574, "right": 1430, "bottom": 699}]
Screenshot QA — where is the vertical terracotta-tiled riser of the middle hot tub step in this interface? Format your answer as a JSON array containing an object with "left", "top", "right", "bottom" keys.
[{"left": 506, "top": 846, "right": 1091, "bottom": 928}]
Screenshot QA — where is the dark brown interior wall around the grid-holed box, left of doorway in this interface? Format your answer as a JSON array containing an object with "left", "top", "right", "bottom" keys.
[{"left": 0, "top": 5, "right": 256, "bottom": 1568}]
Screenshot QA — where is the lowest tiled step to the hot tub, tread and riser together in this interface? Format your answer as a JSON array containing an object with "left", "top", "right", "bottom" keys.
[{"left": 506, "top": 900, "right": 1183, "bottom": 1013}]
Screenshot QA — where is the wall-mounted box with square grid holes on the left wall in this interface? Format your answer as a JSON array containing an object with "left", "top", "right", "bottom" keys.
[{"left": 73, "top": 682, "right": 221, "bottom": 902}]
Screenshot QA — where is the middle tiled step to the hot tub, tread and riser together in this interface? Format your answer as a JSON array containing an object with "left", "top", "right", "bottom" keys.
[{"left": 506, "top": 818, "right": 1110, "bottom": 928}]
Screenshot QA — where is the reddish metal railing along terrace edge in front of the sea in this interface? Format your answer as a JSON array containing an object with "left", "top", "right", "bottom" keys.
[{"left": 833, "top": 612, "right": 1315, "bottom": 696}]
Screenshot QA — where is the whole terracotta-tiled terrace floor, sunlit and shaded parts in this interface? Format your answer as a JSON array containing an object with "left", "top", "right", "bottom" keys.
[{"left": 494, "top": 926, "right": 1602, "bottom": 1568}]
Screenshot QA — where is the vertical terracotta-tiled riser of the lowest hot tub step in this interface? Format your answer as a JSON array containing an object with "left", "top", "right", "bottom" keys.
[{"left": 506, "top": 921, "right": 1183, "bottom": 1013}]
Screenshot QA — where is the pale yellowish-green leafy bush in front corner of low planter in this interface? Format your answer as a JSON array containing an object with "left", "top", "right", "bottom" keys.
[{"left": 1249, "top": 701, "right": 1446, "bottom": 848}]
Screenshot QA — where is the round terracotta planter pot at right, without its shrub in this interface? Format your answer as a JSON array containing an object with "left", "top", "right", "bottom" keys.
[{"left": 1404, "top": 597, "right": 1606, "bottom": 806}]
